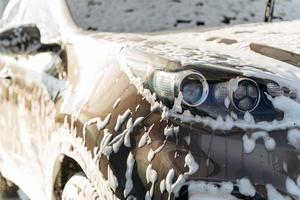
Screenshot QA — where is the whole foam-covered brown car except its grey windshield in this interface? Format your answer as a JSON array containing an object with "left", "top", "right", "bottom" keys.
[{"left": 0, "top": 1, "right": 300, "bottom": 200}]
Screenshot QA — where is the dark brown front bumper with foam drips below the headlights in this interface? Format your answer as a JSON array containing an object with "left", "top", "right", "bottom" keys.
[{"left": 133, "top": 112, "right": 300, "bottom": 198}]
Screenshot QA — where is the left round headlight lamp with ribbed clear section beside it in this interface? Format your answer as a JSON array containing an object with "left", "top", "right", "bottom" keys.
[{"left": 153, "top": 70, "right": 209, "bottom": 107}]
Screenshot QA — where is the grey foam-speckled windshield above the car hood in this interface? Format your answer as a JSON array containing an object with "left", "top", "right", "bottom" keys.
[{"left": 67, "top": 0, "right": 300, "bottom": 32}]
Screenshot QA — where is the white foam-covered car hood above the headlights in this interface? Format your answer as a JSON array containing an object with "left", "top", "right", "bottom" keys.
[{"left": 94, "top": 20, "right": 300, "bottom": 90}]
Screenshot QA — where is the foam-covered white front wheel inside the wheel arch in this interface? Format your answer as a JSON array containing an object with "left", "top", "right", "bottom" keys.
[{"left": 62, "top": 173, "right": 100, "bottom": 200}]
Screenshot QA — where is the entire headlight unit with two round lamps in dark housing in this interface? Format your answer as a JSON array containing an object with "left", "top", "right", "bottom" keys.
[{"left": 145, "top": 70, "right": 286, "bottom": 121}]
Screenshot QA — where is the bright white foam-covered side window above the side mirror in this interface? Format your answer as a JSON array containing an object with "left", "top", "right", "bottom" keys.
[{"left": 0, "top": 0, "right": 59, "bottom": 42}]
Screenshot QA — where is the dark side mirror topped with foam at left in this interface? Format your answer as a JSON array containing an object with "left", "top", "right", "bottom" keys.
[{"left": 0, "top": 24, "right": 61, "bottom": 55}]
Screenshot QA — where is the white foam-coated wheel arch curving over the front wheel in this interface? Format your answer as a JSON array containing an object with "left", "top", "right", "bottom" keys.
[{"left": 50, "top": 123, "right": 118, "bottom": 199}]
